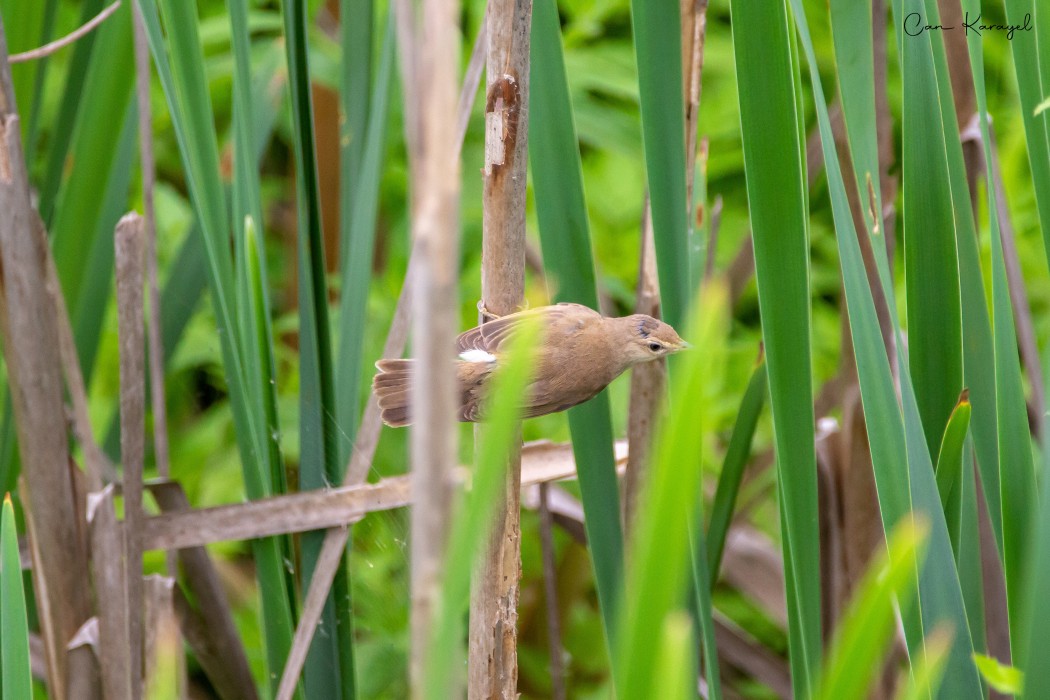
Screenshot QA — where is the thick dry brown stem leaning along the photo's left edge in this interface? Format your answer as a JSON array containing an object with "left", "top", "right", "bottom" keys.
[{"left": 0, "top": 24, "right": 90, "bottom": 698}]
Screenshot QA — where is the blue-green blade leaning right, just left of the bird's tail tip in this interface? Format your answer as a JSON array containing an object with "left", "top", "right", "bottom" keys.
[{"left": 336, "top": 9, "right": 395, "bottom": 464}]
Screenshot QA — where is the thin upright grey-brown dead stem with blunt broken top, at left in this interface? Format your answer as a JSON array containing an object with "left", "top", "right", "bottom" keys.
[{"left": 113, "top": 213, "right": 146, "bottom": 698}]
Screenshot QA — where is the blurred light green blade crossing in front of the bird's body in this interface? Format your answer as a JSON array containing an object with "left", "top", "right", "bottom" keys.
[{"left": 423, "top": 320, "right": 541, "bottom": 700}]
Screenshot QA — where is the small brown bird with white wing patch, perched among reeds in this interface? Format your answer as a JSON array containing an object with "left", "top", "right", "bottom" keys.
[{"left": 372, "top": 303, "right": 689, "bottom": 427}]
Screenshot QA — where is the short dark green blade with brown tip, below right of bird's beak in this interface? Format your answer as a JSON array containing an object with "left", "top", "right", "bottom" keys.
[{"left": 708, "top": 359, "right": 769, "bottom": 586}]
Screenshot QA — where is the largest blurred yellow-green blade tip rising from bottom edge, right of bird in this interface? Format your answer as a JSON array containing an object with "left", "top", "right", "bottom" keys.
[{"left": 819, "top": 519, "right": 929, "bottom": 700}]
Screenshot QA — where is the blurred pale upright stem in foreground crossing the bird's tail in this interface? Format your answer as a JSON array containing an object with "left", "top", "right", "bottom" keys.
[{"left": 405, "top": 0, "right": 460, "bottom": 698}]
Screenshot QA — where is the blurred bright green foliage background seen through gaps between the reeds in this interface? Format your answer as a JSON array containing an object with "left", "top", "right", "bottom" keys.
[{"left": 0, "top": 0, "right": 1050, "bottom": 698}]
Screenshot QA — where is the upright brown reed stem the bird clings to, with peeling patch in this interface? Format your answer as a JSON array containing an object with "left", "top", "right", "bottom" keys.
[{"left": 467, "top": 0, "right": 532, "bottom": 700}]
